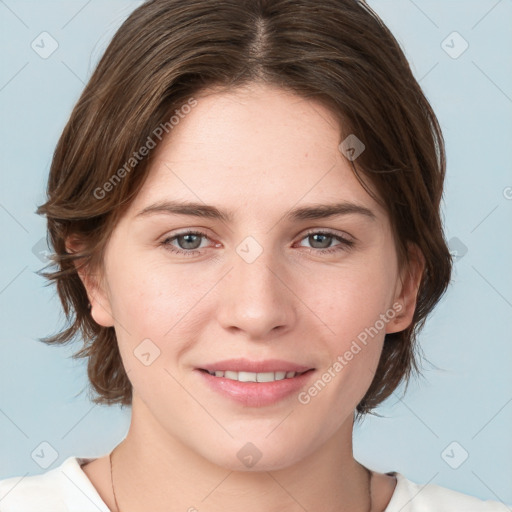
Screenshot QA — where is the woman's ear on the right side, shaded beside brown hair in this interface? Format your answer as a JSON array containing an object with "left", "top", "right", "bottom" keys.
[{"left": 386, "top": 243, "right": 425, "bottom": 333}]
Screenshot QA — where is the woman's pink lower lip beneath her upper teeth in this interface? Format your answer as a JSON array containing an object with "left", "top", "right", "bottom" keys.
[{"left": 196, "top": 370, "right": 314, "bottom": 407}]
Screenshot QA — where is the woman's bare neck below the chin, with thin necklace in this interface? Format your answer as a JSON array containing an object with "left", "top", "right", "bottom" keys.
[{"left": 112, "top": 402, "right": 371, "bottom": 512}]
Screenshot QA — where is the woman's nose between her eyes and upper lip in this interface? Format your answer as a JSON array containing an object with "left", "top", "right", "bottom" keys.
[{"left": 217, "top": 243, "right": 298, "bottom": 341}]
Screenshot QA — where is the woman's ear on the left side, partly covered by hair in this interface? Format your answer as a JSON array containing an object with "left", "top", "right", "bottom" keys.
[{"left": 66, "top": 236, "right": 114, "bottom": 327}]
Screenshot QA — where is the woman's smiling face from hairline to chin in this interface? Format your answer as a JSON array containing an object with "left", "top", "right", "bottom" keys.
[{"left": 83, "top": 85, "right": 415, "bottom": 469}]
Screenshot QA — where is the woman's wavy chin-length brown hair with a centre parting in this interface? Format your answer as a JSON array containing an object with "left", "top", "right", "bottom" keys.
[{"left": 37, "top": 0, "right": 452, "bottom": 419}]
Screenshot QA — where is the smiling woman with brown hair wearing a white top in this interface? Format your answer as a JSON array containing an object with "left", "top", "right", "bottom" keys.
[{"left": 0, "top": 0, "right": 506, "bottom": 512}]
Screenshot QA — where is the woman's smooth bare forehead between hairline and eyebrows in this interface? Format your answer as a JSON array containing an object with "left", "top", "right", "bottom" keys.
[{"left": 126, "top": 87, "right": 386, "bottom": 220}]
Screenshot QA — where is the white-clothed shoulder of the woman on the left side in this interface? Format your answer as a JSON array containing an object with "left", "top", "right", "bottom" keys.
[{"left": 0, "top": 457, "right": 109, "bottom": 512}]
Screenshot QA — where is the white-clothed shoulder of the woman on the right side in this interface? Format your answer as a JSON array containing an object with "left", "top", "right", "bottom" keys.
[{"left": 384, "top": 472, "right": 512, "bottom": 512}]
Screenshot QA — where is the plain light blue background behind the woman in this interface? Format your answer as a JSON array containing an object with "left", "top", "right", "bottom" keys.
[{"left": 0, "top": 0, "right": 512, "bottom": 503}]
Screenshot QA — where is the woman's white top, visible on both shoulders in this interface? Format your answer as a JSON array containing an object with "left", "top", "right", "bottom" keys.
[{"left": 0, "top": 457, "right": 512, "bottom": 512}]
